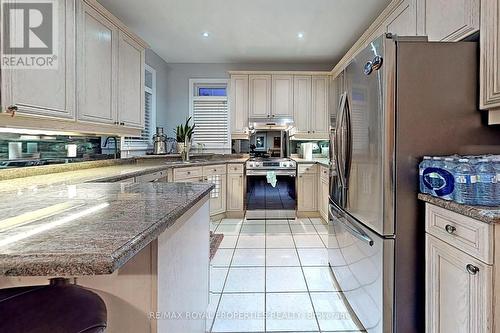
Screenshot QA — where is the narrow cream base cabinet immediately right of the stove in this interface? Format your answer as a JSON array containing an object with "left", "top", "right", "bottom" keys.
[{"left": 297, "top": 164, "right": 318, "bottom": 216}]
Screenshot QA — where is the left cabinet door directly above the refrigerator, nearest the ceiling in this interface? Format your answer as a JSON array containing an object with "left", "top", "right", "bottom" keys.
[{"left": 382, "top": 0, "right": 417, "bottom": 38}]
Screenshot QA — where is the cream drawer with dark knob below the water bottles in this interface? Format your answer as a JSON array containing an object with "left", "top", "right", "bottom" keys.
[{"left": 425, "top": 204, "right": 494, "bottom": 264}]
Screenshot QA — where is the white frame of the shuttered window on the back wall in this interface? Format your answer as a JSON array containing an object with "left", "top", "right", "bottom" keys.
[{"left": 189, "top": 78, "right": 231, "bottom": 151}]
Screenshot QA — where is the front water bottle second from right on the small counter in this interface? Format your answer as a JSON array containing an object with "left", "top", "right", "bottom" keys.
[{"left": 454, "top": 158, "right": 476, "bottom": 205}]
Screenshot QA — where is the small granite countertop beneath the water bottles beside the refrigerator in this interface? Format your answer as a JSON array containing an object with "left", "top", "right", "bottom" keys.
[{"left": 418, "top": 193, "right": 500, "bottom": 223}]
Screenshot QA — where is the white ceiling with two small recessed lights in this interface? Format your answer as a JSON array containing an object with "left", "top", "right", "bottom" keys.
[{"left": 99, "top": 0, "right": 390, "bottom": 64}]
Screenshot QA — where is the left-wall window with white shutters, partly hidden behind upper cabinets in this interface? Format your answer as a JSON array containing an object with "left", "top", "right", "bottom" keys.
[{"left": 122, "top": 65, "right": 156, "bottom": 150}]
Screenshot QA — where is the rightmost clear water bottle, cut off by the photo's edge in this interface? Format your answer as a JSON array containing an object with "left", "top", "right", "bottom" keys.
[{"left": 476, "top": 158, "right": 497, "bottom": 206}]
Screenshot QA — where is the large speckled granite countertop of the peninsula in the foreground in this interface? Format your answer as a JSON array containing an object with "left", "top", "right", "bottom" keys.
[{"left": 0, "top": 183, "right": 213, "bottom": 276}]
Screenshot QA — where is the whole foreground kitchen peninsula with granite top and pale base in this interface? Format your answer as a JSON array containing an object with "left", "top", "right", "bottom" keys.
[{"left": 0, "top": 183, "right": 213, "bottom": 332}]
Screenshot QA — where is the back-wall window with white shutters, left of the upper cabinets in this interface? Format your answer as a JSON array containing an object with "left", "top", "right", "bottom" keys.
[{"left": 189, "top": 79, "right": 231, "bottom": 150}]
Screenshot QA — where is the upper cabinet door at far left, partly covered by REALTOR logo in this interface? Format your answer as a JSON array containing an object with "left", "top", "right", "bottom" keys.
[{"left": 0, "top": 0, "right": 75, "bottom": 119}]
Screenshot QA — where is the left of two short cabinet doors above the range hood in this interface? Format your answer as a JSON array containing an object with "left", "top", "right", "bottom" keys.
[{"left": 248, "top": 75, "right": 271, "bottom": 118}]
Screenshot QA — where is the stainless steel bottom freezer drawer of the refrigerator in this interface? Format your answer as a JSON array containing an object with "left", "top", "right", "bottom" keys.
[{"left": 328, "top": 203, "right": 394, "bottom": 333}]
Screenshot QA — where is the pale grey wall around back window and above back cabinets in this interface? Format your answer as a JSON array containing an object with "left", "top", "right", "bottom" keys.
[{"left": 158, "top": 62, "right": 333, "bottom": 137}]
